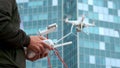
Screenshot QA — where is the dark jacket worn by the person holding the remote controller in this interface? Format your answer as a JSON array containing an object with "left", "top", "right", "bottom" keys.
[{"left": 0, "top": 0, "right": 30, "bottom": 68}]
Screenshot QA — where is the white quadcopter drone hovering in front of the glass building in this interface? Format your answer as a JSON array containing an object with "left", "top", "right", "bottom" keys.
[{"left": 65, "top": 16, "right": 95, "bottom": 32}]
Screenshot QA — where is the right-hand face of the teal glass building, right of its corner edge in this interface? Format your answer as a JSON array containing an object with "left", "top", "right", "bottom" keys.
[{"left": 78, "top": 0, "right": 120, "bottom": 68}]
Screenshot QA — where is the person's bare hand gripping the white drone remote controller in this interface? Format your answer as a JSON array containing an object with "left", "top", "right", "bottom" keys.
[{"left": 27, "top": 36, "right": 52, "bottom": 61}]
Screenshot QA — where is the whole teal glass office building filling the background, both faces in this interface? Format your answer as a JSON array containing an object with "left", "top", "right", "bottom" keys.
[{"left": 17, "top": 0, "right": 120, "bottom": 68}]
